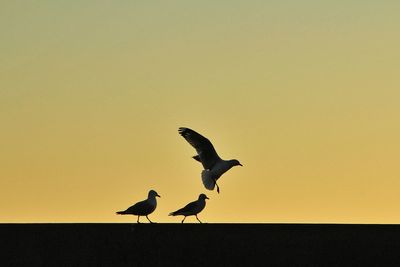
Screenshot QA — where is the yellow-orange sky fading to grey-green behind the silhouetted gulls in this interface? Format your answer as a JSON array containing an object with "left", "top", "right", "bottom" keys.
[{"left": 0, "top": 0, "right": 400, "bottom": 223}]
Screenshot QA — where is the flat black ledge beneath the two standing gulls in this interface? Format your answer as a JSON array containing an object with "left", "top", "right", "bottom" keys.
[{"left": 0, "top": 224, "right": 400, "bottom": 266}]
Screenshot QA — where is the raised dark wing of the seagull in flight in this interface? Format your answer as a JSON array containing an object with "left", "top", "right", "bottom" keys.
[{"left": 178, "top": 127, "right": 221, "bottom": 169}]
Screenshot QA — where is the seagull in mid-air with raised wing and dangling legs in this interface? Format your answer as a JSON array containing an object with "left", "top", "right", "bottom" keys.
[{"left": 178, "top": 127, "right": 243, "bottom": 193}]
